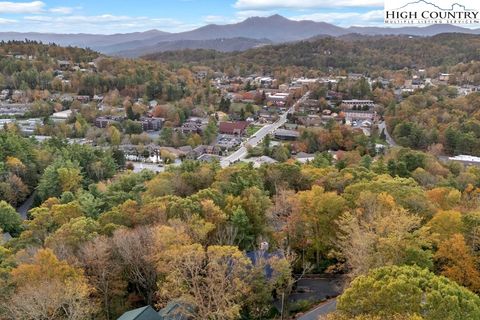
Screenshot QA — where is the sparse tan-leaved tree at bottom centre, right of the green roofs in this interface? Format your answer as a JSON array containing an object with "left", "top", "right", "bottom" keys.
[{"left": 159, "top": 244, "right": 255, "bottom": 320}]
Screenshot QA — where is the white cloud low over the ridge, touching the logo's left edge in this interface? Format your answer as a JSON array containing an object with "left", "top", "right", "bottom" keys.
[{"left": 290, "top": 10, "right": 383, "bottom": 26}]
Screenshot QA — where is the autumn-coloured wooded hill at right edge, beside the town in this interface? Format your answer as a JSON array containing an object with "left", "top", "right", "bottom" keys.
[{"left": 385, "top": 86, "right": 480, "bottom": 156}]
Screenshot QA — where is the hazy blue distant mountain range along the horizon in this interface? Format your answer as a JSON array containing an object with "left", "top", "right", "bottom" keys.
[{"left": 0, "top": 15, "right": 480, "bottom": 57}]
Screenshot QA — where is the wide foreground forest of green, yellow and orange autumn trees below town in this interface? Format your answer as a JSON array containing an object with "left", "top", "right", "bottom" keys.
[{"left": 0, "top": 128, "right": 480, "bottom": 319}]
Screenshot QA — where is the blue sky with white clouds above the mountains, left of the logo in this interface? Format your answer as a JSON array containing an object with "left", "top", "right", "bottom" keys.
[{"left": 0, "top": 0, "right": 383, "bottom": 34}]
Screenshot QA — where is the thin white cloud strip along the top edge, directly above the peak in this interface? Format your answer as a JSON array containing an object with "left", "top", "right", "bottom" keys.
[{"left": 234, "top": 0, "right": 383, "bottom": 10}]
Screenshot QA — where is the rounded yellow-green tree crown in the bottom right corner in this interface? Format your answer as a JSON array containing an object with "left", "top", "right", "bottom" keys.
[{"left": 337, "top": 266, "right": 480, "bottom": 320}]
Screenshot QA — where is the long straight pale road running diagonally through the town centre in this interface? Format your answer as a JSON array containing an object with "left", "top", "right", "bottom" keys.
[{"left": 220, "top": 91, "right": 310, "bottom": 168}]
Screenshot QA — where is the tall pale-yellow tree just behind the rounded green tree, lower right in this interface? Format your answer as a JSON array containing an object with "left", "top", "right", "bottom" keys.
[{"left": 338, "top": 192, "right": 432, "bottom": 277}]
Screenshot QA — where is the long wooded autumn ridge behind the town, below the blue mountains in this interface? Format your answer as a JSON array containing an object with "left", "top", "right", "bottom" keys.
[{"left": 145, "top": 33, "right": 480, "bottom": 73}]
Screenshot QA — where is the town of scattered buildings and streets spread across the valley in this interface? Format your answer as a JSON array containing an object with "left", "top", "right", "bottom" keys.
[{"left": 0, "top": 54, "right": 480, "bottom": 172}]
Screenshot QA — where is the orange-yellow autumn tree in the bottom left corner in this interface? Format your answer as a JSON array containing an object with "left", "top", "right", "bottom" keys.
[{"left": 4, "top": 249, "right": 95, "bottom": 320}]
